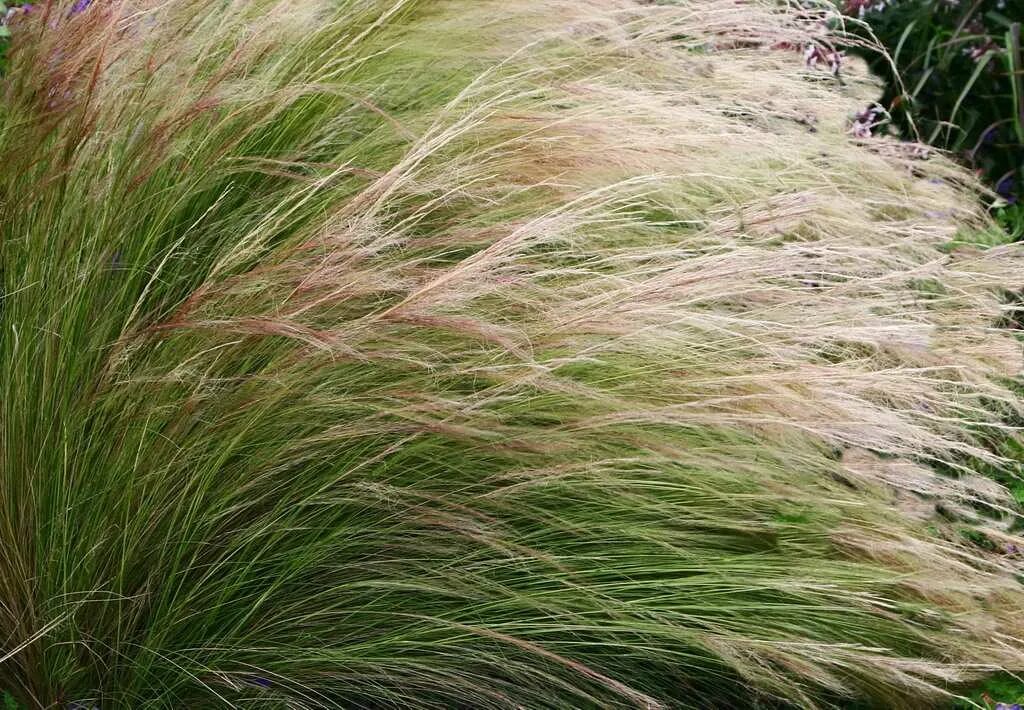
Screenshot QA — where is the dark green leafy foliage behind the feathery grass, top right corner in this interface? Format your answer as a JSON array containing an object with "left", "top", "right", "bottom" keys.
[{"left": 844, "top": 0, "right": 1024, "bottom": 239}]
